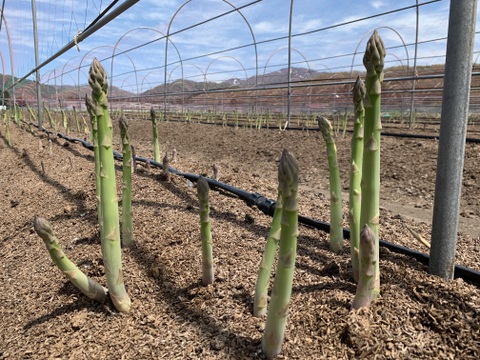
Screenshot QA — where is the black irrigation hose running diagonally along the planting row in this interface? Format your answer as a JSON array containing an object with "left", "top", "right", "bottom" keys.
[{"left": 29, "top": 124, "right": 480, "bottom": 285}]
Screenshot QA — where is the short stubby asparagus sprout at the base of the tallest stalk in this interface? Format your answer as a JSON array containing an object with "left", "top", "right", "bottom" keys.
[{"left": 352, "top": 225, "right": 377, "bottom": 310}]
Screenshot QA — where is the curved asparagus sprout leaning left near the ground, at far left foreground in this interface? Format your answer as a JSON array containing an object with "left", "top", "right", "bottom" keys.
[{"left": 33, "top": 216, "right": 107, "bottom": 302}]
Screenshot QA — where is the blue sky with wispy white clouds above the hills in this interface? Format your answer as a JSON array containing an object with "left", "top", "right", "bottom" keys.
[{"left": 0, "top": 0, "right": 480, "bottom": 92}]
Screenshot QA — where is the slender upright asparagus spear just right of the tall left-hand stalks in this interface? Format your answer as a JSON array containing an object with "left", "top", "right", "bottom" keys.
[{"left": 119, "top": 115, "right": 133, "bottom": 246}]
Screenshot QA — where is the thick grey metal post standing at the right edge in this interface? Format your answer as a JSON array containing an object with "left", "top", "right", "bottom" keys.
[{"left": 429, "top": 0, "right": 477, "bottom": 279}]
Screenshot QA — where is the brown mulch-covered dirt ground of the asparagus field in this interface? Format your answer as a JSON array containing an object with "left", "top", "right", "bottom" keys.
[{"left": 0, "top": 120, "right": 480, "bottom": 359}]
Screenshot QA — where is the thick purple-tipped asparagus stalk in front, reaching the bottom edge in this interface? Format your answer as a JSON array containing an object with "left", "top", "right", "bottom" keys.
[{"left": 262, "top": 150, "right": 298, "bottom": 358}]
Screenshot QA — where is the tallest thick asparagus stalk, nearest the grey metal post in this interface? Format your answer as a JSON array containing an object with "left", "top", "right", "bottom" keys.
[{"left": 360, "top": 30, "right": 385, "bottom": 295}]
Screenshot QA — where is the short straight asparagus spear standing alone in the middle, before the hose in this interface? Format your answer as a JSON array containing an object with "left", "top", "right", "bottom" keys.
[{"left": 197, "top": 176, "right": 215, "bottom": 286}]
